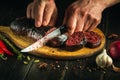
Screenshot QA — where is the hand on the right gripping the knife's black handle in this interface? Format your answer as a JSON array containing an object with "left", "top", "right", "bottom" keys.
[{"left": 63, "top": 0, "right": 105, "bottom": 34}]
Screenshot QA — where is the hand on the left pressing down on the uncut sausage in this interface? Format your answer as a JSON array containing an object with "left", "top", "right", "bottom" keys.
[{"left": 26, "top": 0, "right": 57, "bottom": 27}]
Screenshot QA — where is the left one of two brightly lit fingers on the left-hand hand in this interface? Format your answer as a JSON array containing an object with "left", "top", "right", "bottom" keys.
[{"left": 35, "top": 1, "right": 45, "bottom": 27}]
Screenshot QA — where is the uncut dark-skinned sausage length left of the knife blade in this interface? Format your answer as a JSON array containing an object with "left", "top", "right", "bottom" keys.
[{"left": 10, "top": 18, "right": 56, "bottom": 41}]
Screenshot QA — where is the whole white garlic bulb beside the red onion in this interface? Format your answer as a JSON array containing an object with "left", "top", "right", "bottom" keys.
[{"left": 96, "top": 49, "right": 113, "bottom": 68}]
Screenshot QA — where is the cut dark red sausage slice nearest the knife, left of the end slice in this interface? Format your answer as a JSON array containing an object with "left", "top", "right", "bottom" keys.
[{"left": 65, "top": 32, "right": 86, "bottom": 51}]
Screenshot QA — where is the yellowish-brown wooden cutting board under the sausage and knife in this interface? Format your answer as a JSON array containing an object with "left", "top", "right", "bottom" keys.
[{"left": 0, "top": 26, "right": 105, "bottom": 59}]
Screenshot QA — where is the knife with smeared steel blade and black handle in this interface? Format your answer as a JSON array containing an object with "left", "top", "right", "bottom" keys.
[{"left": 21, "top": 25, "right": 67, "bottom": 52}]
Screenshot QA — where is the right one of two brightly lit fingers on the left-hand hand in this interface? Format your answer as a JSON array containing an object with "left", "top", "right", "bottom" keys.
[{"left": 42, "top": 6, "right": 54, "bottom": 26}]
